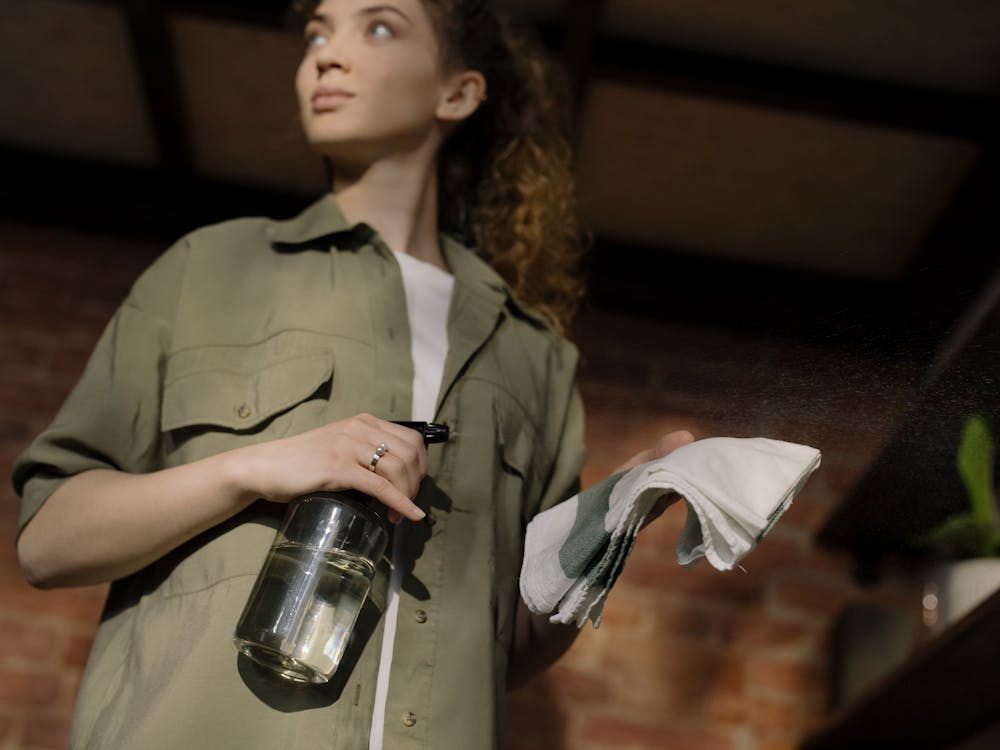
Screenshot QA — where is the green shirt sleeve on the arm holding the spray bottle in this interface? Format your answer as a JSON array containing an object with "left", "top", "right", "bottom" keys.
[{"left": 13, "top": 240, "right": 188, "bottom": 533}]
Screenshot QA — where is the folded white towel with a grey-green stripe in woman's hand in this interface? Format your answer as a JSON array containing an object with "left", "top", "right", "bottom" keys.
[{"left": 520, "top": 437, "right": 820, "bottom": 628}]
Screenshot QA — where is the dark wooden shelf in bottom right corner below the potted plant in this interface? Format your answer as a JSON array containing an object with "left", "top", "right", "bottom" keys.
[{"left": 801, "top": 591, "right": 1000, "bottom": 750}]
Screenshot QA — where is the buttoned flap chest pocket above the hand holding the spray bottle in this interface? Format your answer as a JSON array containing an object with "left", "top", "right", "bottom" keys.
[{"left": 160, "top": 331, "right": 333, "bottom": 450}]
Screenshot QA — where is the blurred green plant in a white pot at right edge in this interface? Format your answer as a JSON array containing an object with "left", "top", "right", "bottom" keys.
[{"left": 922, "top": 415, "right": 1000, "bottom": 630}]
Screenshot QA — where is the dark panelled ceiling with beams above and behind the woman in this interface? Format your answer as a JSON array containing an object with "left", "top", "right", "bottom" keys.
[{"left": 0, "top": 0, "right": 1000, "bottom": 361}]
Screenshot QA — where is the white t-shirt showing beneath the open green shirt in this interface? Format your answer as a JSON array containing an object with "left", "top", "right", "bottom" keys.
[{"left": 368, "top": 252, "right": 455, "bottom": 750}]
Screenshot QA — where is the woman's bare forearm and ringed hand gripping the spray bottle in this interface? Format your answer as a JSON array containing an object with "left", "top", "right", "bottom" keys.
[{"left": 17, "top": 414, "right": 427, "bottom": 588}]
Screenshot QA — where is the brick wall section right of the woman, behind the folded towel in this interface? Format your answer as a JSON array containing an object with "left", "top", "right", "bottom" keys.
[{"left": 507, "top": 313, "right": 916, "bottom": 750}]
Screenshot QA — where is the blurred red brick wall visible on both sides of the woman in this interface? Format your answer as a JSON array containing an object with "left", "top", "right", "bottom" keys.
[{"left": 0, "top": 222, "right": 920, "bottom": 750}]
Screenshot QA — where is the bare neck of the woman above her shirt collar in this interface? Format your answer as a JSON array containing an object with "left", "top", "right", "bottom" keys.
[{"left": 333, "top": 143, "right": 446, "bottom": 268}]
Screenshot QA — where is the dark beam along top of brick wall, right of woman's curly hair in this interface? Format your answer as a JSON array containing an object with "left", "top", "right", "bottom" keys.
[{"left": 588, "top": 238, "right": 924, "bottom": 360}]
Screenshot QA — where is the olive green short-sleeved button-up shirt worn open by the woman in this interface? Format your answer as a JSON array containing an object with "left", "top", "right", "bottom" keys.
[{"left": 14, "top": 195, "right": 583, "bottom": 750}]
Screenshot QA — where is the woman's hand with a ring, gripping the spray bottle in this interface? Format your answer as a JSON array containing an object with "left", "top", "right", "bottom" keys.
[{"left": 229, "top": 414, "right": 427, "bottom": 522}]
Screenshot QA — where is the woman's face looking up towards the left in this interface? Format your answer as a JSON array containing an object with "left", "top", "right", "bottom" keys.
[{"left": 295, "top": 0, "right": 447, "bottom": 163}]
